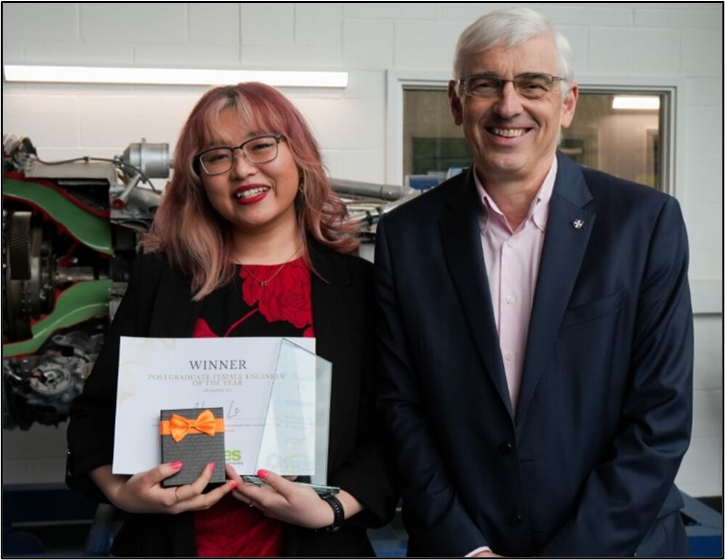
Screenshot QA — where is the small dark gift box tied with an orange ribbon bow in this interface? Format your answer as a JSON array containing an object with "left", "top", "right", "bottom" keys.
[{"left": 159, "top": 407, "right": 226, "bottom": 486}]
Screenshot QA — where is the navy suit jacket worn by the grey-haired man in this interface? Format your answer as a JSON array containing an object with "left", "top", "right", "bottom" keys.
[{"left": 375, "top": 154, "right": 693, "bottom": 556}]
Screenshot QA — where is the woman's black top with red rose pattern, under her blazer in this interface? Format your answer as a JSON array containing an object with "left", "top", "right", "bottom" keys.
[{"left": 193, "top": 258, "right": 314, "bottom": 558}]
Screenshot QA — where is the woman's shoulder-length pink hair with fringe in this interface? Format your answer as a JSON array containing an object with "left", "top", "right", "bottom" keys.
[{"left": 143, "top": 82, "right": 360, "bottom": 300}]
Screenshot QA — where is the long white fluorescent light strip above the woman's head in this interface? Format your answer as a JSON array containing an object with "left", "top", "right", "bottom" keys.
[{"left": 3, "top": 64, "right": 348, "bottom": 88}]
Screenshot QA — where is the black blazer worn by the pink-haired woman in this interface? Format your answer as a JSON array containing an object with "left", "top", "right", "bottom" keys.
[{"left": 66, "top": 243, "right": 396, "bottom": 556}]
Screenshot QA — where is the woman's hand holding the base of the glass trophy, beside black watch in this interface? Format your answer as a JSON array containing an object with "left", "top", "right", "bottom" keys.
[{"left": 227, "top": 465, "right": 340, "bottom": 529}]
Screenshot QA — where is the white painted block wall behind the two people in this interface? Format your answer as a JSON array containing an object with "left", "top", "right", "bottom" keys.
[{"left": 3, "top": 2, "right": 722, "bottom": 496}]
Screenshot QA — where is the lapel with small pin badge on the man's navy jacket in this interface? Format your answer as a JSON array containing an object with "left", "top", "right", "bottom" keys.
[{"left": 516, "top": 154, "right": 596, "bottom": 425}]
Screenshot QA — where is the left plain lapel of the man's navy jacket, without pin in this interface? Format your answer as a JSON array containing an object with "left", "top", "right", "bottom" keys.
[{"left": 441, "top": 167, "right": 513, "bottom": 415}]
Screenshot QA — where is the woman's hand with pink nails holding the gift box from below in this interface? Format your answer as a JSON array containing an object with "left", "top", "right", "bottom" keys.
[{"left": 90, "top": 462, "right": 238, "bottom": 513}]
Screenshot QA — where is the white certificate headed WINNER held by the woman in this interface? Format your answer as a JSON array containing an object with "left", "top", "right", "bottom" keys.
[{"left": 113, "top": 337, "right": 316, "bottom": 475}]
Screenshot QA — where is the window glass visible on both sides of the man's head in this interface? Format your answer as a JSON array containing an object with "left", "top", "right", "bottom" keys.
[{"left": 402, "top": 86, "right": 672, "bottom": 190}]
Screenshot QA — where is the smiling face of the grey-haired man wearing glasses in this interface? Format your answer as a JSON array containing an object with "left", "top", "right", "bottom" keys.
[{"left": 448, "top": 35, "right": 579, "bottom": 184}]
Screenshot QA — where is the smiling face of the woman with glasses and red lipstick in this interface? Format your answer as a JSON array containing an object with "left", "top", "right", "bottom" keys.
[{"left": 200, "top": 111, "right": 300, "bottom": 234}]
